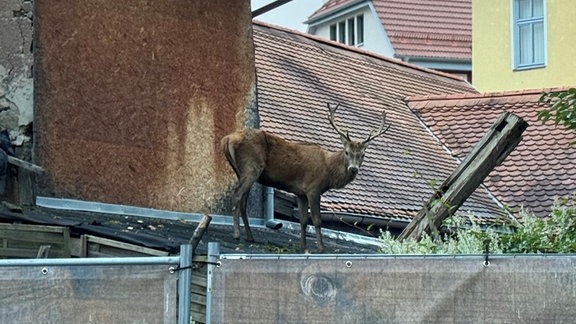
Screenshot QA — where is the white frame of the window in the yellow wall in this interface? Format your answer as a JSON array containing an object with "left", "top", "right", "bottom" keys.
[{"left": 511, "top": 0, "right": 548, "bottom": 71}]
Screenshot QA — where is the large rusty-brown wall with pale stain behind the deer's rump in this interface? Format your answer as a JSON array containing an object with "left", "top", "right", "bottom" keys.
[{"left": 34, "top": 0, "right": 255, "bottom": 212}]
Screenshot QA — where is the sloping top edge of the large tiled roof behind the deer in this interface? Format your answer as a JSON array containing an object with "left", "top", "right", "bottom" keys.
[{"left": 252, "top": 19, "right": 466, "bottom": 82}]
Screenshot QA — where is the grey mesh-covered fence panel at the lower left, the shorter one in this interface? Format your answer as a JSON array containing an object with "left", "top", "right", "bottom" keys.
[{"left": 0, "top": 258, "right": 178, "bottom": 323}]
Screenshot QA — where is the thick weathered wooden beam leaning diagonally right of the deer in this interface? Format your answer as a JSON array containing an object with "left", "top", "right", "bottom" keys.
[{"left": 398, "top": 112, "right": 528, "bottom": 241}]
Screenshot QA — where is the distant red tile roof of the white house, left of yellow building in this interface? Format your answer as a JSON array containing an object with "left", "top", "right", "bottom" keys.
[{"left": 310, "top": 0, "right": 472, "bottom": 61}]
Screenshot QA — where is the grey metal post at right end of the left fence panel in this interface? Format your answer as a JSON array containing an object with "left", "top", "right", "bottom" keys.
[{"left": 178, "top": 244, "right": 192, "bottom": 324}]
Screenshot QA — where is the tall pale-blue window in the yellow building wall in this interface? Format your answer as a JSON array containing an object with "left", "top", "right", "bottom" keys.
[{"left": 513, "top": 0, "right": 546, "bottom": 70}]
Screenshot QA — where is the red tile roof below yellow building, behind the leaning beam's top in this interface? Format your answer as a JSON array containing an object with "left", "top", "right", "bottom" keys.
[{"left": 407, "top": 89, "right": 576, "bottom": 216}]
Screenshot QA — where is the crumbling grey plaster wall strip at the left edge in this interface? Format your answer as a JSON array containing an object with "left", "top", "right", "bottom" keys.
[{"left": 0, "top": 0, "right": 34, "bottom": 146}]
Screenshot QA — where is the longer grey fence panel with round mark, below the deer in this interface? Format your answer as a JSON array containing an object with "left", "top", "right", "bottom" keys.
[{"left": 211, "top": 256, "right": 576, "bottom": 323}]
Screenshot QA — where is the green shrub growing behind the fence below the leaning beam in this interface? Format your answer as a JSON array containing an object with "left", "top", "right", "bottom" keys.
[{"left": 380, "top": 195, "right": 576, "bottom": 254}]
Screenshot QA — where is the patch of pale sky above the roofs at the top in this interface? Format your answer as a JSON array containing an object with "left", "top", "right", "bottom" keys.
[{"left": 251, "top": 0, "right": 324, "bottom": 32}]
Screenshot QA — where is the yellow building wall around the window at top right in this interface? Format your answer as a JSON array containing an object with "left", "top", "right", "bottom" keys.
[{"left": 472, "top": 0, "right": 576, "bottom": 92}]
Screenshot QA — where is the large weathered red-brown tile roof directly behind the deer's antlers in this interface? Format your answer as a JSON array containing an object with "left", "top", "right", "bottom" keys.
[{"left": 254, "top": 22, "right": 498, "bottom": 220}]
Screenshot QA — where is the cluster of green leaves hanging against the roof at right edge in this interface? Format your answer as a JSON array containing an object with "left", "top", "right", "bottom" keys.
[{"left": 536, "top": 88, "right": 576, "bottom": 130}]
